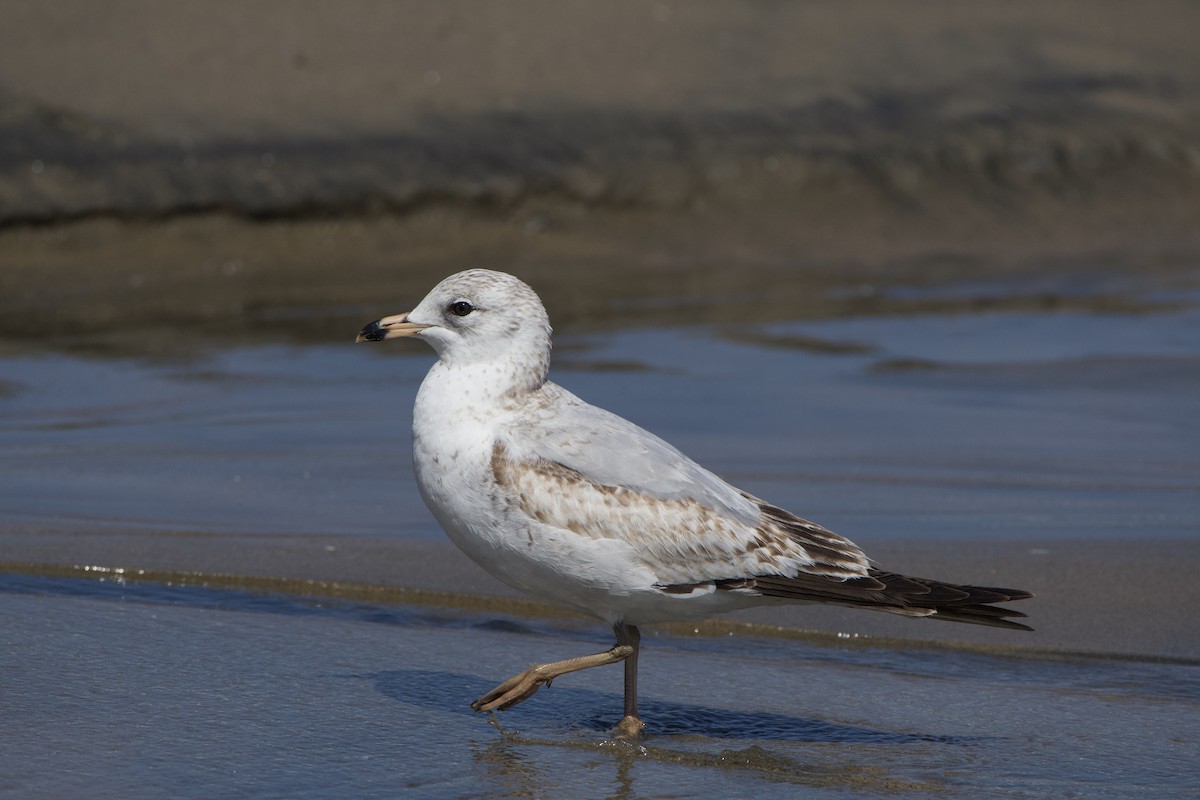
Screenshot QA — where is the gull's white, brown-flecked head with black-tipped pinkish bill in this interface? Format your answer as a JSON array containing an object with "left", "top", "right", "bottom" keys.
[{"left": 358, "top": 270, "right": 550, "bottom": 378}]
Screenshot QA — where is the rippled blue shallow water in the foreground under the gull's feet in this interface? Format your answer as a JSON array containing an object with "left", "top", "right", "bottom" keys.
[{"left": 0, "top": 575, "right": 1200, "bottom": 800}]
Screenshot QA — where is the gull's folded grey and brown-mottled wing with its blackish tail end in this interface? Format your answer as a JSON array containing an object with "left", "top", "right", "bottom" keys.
[{"left": 492, "top": 383, "right": 1031, "bottom": 630}]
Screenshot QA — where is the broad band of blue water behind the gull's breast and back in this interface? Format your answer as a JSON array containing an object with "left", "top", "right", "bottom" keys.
[{"left": 0, "top": 306, "right": 1200, "bottom": 540}]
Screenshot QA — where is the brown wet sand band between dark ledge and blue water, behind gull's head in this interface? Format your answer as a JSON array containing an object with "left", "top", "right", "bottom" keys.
[{"left": 0, "top": 204, "right": 1200, "bottom": 355}]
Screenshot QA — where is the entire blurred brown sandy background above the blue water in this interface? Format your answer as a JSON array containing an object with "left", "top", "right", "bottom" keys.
[{"left": 7, "top": 0, "right": 1200, "bottom": 349}]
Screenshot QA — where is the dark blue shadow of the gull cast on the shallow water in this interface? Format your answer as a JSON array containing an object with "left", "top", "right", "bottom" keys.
[{"left": 358, "top": 669, "right": 976, "bottom": 745}]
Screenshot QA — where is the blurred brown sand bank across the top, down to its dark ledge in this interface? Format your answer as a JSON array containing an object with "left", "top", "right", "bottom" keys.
[{"left": 0, "top": 0, "right": 1200, "bottom": 237}]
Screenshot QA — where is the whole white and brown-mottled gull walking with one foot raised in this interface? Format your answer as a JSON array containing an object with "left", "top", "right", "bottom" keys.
[{"left": 356, "top": 270, "right": 1032, "bottom": 739}]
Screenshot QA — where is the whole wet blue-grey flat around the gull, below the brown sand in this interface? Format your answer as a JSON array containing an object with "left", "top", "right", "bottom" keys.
[{"left": 0, "top": 272, "right": 1200, "bottom": 798}]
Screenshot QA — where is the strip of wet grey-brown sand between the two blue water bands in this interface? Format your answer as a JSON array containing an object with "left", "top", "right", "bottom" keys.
[{"left": 0, "top": 524, "right": 1200, "bottom": 664}]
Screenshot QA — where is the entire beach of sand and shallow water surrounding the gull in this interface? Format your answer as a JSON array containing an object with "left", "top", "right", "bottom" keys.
[{"left": 0, "top": 0, "right": 1200, "bottom": 798}]
